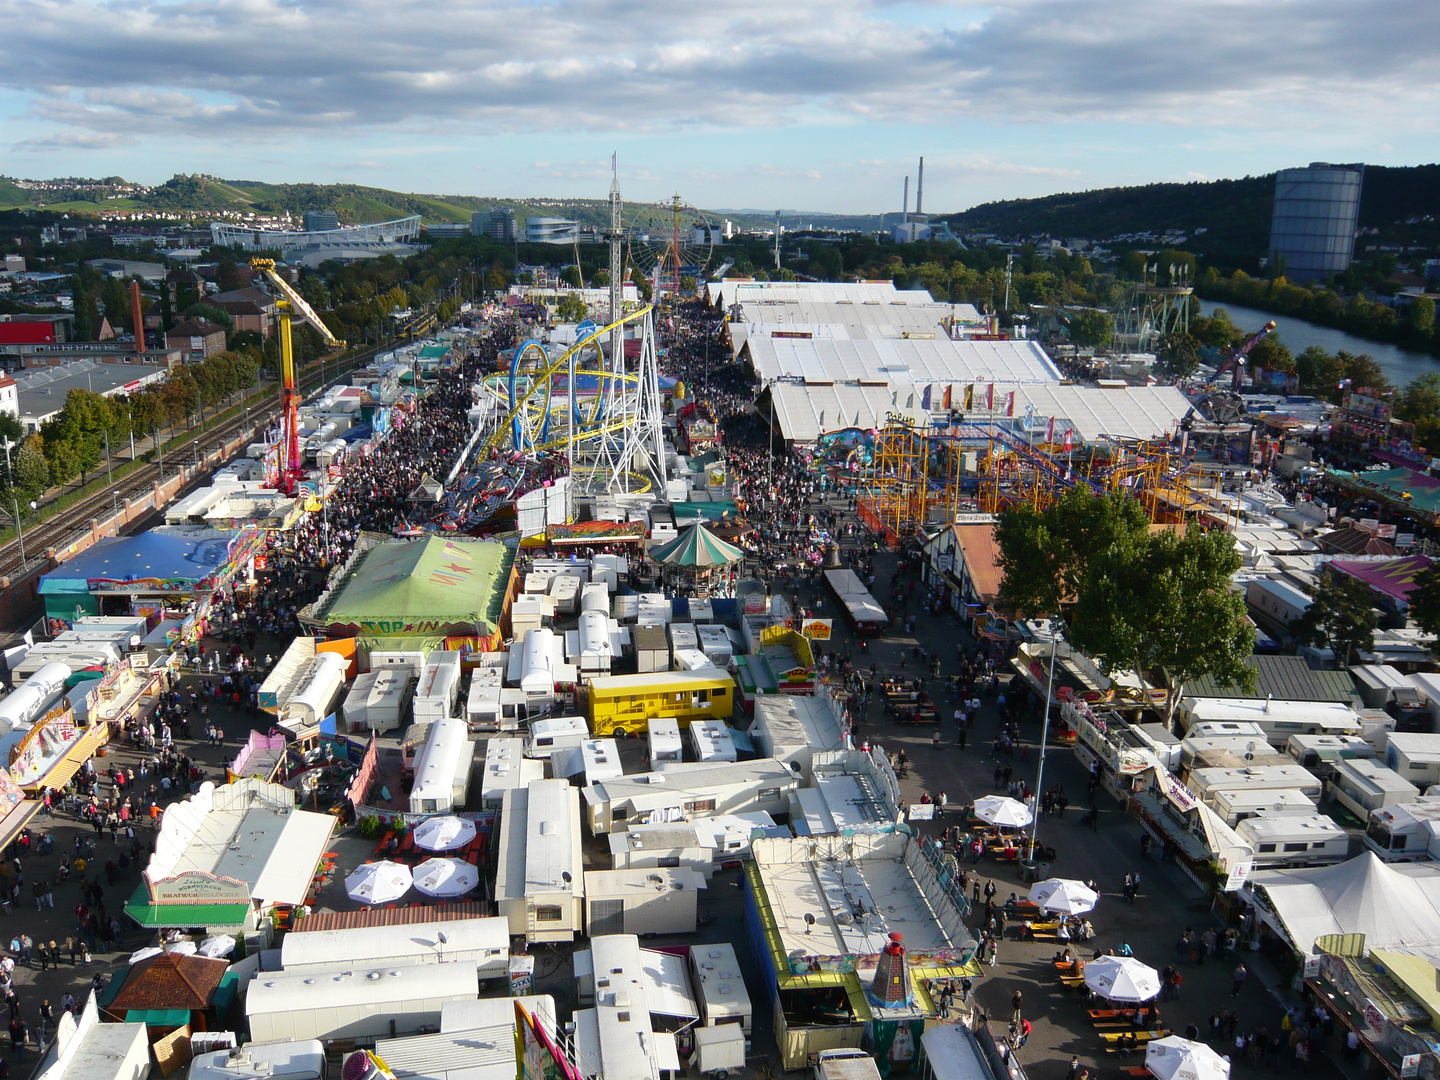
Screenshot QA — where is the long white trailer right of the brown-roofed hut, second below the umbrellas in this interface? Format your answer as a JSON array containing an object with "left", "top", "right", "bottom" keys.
[{"left": 245, "top": 963, "right": 480, "bottom": 1044}]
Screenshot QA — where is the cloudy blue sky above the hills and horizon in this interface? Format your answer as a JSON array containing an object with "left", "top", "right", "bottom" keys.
[{"left": 0, "top": 0, "right": 1440, "bottom": 213}]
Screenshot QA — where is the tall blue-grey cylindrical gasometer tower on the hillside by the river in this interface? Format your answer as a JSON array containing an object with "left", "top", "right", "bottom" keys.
[{"left": 1270, "top": 161, "right": 1365, "bottom": 281}]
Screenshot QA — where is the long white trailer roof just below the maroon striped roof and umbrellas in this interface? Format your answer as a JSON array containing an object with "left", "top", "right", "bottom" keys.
[{"left": 279, "top": 917, "right": 510, "bottom": 979}]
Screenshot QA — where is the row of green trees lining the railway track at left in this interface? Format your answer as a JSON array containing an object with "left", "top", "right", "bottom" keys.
[{"left": 0, "top": 351, "right": 259, "bottom": 501}]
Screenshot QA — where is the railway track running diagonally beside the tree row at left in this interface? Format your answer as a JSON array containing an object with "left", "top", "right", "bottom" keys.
[{"left": 0, "top": 343, "right": 377, "bottom": 579}]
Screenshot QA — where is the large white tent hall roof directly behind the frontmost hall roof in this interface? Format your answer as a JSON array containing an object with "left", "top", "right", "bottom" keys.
[{"left": 744, "top": 337, "right": 1060, "bottom": 386}]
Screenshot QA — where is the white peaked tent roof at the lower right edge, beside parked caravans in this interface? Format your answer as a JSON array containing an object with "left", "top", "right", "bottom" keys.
[{"left": 1247, "top": 851, "right": 1440, "bottom": 955}]
